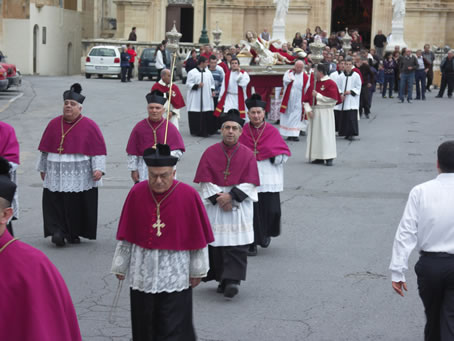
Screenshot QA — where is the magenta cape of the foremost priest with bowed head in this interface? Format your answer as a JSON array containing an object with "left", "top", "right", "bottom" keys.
[{"left": 117, "top": 180, "right": 214, "bottom": 251}]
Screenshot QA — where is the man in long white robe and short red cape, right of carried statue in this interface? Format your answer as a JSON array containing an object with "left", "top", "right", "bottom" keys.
[{"left": 304, "top": 64, "right": 342, "bottom": 166}]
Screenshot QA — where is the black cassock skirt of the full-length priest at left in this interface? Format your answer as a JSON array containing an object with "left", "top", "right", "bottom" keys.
[{"left": 43, "top": 187, "right": 98, "bottom": 239}]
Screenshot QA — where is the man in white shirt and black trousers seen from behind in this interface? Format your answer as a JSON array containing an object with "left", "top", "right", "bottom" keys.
[{"left": 389, "top": 141, "right": 454, "bottom": 340}]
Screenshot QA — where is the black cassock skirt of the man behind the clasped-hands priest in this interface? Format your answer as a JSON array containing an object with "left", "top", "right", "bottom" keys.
[{"left": 254, "top": 192, "right": 281, "bottom": 246}]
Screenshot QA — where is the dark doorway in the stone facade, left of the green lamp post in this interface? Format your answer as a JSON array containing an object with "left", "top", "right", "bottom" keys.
[{"left": 166, "top": 5, "right": 194, "bottom": 43}]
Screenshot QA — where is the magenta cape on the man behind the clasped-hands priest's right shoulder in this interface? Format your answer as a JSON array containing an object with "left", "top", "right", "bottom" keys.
[{"left": 239, "top": 122, "right": 291, "bottom": 161}]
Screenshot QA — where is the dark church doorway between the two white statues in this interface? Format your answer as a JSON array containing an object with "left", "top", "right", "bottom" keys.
[{"left": 331, "top": 0, "right": 372, "bottom": 48}]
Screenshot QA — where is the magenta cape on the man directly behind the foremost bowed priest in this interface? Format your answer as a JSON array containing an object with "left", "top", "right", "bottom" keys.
[{"left": 126, "top": 118, "right": 185, "bottom": 156}]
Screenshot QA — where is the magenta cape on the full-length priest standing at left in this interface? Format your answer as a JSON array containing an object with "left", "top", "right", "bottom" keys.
[{"left": 38, "top": 116, "right": 107, "bottom": 156}]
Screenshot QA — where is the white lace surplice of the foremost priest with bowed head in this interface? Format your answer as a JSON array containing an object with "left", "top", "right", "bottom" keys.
[{"left": 111, "top": 241, "right": 209, "bottom": 294}]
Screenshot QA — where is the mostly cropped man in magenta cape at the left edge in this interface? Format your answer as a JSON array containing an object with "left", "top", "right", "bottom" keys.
[{"left": 0, "top": 121, "right": 20, "bottom": 235}]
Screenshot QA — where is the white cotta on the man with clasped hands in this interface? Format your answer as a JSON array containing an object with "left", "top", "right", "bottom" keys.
[{"left": 200, "top": 182, "right": 258, "bottom": 246}]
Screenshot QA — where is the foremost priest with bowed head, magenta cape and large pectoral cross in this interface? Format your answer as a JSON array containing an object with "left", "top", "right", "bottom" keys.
[{"left": 111, "top": 144, "right": 214, "bottom": 341}]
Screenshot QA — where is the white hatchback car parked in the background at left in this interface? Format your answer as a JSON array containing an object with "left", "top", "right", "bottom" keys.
[{"left": 85, "top": 46, "right": 121, "bottom": 78}]
